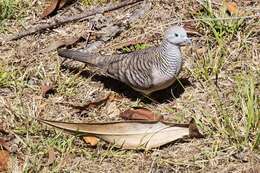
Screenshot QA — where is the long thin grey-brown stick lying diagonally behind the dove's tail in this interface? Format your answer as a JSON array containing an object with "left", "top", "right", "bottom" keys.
[{"left": 7, "top": 0, "right": 143, "bottom": 41}]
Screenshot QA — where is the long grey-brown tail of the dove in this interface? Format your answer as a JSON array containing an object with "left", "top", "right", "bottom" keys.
[{"left": 58, "top": 49, "right": 110, "bottom": 67}]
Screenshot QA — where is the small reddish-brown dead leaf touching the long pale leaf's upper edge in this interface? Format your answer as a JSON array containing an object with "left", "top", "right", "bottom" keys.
[{"left": 119, "top": 108, "right": 163, "bottom": 121}]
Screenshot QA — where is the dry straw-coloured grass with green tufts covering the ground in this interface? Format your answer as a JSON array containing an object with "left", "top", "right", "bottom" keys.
[{"left": 0, "top": 0, "right": 260, "bottom": 172}]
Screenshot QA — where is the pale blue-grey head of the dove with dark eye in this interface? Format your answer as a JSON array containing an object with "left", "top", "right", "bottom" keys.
[{"left": 164, "top": 25, "right": 191, "bottom": 46}]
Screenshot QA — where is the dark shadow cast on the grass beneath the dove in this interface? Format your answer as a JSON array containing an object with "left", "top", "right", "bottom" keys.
[{"left": 61, "top": 64, "right": 192, "bottom": 104}]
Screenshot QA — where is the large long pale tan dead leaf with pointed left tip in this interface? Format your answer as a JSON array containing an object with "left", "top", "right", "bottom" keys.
[{"left": 39, "top": 119, "right": 203, "bottom": 150}]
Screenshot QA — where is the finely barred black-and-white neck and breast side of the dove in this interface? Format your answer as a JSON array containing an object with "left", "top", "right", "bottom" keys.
[{"left": 158, "top": 40, "right": 182, "bottom": 76}]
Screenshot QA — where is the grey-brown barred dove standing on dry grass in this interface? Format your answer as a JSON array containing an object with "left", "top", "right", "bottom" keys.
[{"left": 58, "top": 26, "right": 191, "bottom": 95}]
